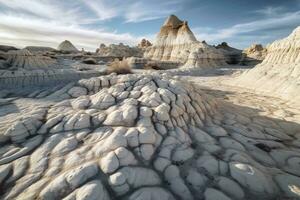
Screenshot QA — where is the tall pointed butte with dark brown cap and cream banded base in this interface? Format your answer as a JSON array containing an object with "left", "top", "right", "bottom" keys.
[{"left": 144, "top": 15, "right": 226, "bottom": 68}]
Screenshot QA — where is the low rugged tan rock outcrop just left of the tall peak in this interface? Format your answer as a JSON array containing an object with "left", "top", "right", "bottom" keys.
[{"left": 96, "top": 43, "right": 143, "bottom": 58}]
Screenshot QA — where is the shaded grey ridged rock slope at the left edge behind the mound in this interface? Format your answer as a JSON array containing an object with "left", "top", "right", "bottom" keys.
[{"left": 0, "top": 49, "right": 103, "bottom": 89}]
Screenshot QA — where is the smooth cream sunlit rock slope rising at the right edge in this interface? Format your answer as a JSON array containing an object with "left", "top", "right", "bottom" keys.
[{"left": 235, "top": 27, "right": 300, "bottom": 101}]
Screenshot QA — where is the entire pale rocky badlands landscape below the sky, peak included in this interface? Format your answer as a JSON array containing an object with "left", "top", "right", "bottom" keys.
[{"left": 0, "top": 15, "right": 300, "bottom": 200}]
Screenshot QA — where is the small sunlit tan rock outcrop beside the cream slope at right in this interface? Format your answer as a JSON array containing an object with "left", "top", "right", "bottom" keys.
[{"left": 240, "top": 44, "right": 267, "bottom": 65}]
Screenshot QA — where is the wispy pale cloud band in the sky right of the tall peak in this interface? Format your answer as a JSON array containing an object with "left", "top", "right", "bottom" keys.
[{"left": 193, "top": 8, "right": 300, "bottom": 47}]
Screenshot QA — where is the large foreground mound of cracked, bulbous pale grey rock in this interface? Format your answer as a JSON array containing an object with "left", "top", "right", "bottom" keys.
[{"left": 0, "top": 74, "right": 300, "bottom": 200}]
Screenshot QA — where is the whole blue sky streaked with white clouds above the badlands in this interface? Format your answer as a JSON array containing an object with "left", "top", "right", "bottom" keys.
[{"left": 0, "top": 0, "right": 300, "bottom": 51}]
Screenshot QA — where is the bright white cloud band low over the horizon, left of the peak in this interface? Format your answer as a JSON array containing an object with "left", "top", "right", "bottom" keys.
[{"left": 0, "top": 14, "right": 141, "bottom": 51}]
